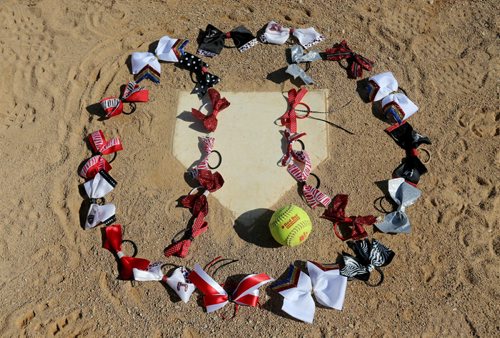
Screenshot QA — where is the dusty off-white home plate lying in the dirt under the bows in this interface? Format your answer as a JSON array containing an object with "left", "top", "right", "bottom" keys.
[{"left": 173, "top": 90, "right": 328, "bottom": 223}]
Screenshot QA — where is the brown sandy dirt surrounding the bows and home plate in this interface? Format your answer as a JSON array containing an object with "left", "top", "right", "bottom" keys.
[{"left": 0, "top": 0, "right": 500, "bottom": 337}]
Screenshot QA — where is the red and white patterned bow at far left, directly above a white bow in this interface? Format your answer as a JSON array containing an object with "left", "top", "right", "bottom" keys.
[{"left": 80, "top": 130, "right": 123, "bottom": 179}]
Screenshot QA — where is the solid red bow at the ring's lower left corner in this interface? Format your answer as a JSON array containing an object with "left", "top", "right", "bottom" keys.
[{"left": 102, "top": 224, "right": 150, "bottom": 280}]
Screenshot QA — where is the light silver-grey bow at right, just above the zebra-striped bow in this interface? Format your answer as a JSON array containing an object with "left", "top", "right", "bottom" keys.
[{"left": 375, "top": 178, "right": 422, "bottom": 234}]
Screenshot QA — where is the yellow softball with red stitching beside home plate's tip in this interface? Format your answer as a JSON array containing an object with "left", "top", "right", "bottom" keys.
[{"left": 269, "top": 204, "right": 312, "bottom": 246}]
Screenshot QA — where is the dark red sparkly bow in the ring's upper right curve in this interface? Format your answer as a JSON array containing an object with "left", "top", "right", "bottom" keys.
[{"left": 325, "top": 40, "right": 374, "bottom": 79}]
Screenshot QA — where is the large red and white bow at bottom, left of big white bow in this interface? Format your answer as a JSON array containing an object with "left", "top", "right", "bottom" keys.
[{"left": 188, "top": 264, "right": 273, "bottom": 313}]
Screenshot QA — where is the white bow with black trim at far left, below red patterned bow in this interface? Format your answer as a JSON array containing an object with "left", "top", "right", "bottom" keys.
[{"left": 83, "top": 170, "right": 116, "bottom": 229}]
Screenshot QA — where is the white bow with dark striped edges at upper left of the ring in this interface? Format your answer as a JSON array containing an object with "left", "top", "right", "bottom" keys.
[{"left": 131, "top": 35, "right": 189, "bottom": 83}]
